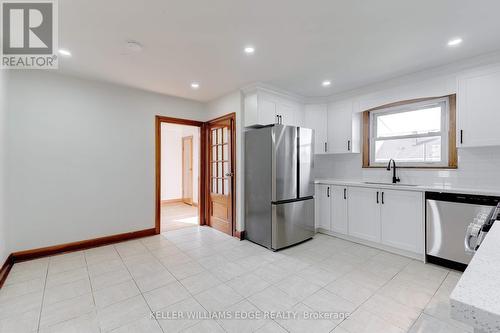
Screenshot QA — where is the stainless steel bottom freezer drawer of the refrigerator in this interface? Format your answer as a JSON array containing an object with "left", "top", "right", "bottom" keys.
[{"left": 272, "top": 198, "right": 314, "bottom": 250}]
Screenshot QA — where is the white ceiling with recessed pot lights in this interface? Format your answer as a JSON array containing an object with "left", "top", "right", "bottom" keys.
[{"left": 59, "top": 0, "right": 500, "bottom": 101}]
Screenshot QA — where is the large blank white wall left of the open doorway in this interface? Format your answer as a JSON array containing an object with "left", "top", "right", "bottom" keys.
[{"left": 7, "top": 71, "right": 206, "bottom": 251}]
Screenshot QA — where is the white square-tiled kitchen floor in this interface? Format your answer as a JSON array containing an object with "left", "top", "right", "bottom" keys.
[{"left": 0, "top": 227, "right": 472, "bottom": 333}]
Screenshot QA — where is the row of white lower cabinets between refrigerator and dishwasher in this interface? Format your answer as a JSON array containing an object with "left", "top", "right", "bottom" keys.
[{"left": 316, "top": 184, "right": 424, "bottom": 256}]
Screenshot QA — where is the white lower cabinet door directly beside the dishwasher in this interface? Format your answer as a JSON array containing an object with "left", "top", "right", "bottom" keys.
[{"left": 380, "top": 190, "right": 424, "bottom": 253}]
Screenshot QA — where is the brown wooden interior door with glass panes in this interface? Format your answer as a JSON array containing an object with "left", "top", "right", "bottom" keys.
[{"left": 207, "top": 119, "right": 234, "bottom": 235}]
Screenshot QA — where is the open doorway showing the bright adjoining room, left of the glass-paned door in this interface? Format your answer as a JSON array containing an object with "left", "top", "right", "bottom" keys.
[{"left": 156, "top": 117, "right": 204, "bottom": 233}]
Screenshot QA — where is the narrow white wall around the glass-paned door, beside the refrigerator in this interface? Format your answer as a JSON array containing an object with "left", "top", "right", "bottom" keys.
[{"left": 205, "top": 90, "right": 245, "bottom": 230}]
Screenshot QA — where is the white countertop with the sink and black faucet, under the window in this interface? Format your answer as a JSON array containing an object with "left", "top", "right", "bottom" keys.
[{"left": 315, "top": 179, "right": 500, "bottom": 196}]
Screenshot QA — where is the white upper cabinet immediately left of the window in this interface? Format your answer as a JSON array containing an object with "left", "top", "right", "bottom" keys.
[{"left": 328, "top": 102, "right": 361, "bottom": 154}]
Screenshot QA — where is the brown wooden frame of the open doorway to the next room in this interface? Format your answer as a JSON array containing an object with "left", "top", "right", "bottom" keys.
[{"left": 155, "top": 116, "right": 207, "bottom": 234}]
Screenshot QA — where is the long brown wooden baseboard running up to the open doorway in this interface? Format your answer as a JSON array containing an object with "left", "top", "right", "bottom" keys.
[{"left": 11, "top": 228, "right": 156, "bottom": 263}]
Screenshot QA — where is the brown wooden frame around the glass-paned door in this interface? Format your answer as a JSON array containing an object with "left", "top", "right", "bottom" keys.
[{"left": 200, "top": 112, "right": 236, "bottom": 238}]
